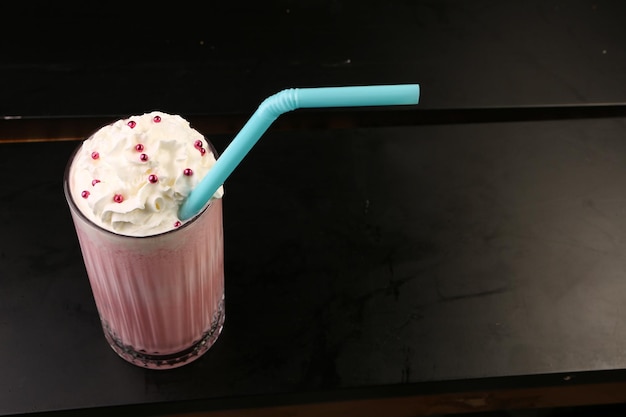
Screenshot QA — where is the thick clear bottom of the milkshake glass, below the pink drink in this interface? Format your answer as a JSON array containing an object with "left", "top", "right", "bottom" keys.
[{"left": 102, "top": 302, "right": 225, "bottom": 369}]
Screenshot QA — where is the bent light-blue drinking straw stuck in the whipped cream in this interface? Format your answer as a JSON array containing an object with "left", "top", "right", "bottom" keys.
[{"left": 178, "top": 84, "right": 420, "bottom": 220}]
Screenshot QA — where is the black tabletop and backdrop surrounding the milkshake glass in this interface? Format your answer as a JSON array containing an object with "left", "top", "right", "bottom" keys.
[{"left": 0, "top": 1, "right": 626, "bottom": 416}]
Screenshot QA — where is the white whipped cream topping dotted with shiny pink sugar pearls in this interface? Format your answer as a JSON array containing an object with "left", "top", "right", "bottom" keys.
[{"left": 69, "top": 111, "right": 224, "bottom": 236}]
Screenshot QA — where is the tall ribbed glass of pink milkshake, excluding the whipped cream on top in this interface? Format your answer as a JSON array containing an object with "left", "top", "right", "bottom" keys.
[{"left": 63, "top": 138, "right": 224, "bottom": 369}]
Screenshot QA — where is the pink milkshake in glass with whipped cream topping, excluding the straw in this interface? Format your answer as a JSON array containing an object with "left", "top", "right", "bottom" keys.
[{"left": 64, "top": 112, "right": 224, "bottom": 369}]
